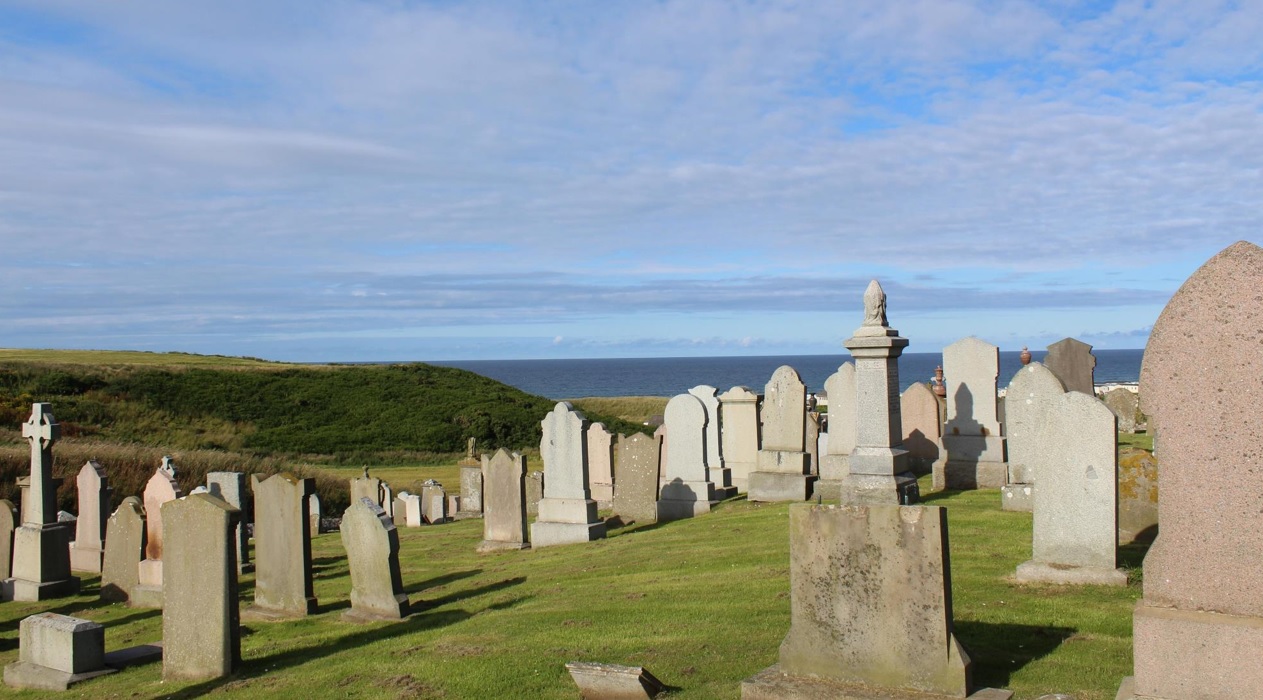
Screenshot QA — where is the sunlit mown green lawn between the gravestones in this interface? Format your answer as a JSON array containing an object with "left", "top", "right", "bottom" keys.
[{"left": 0, "top": 468, "right": 1140, "bottom": 700}]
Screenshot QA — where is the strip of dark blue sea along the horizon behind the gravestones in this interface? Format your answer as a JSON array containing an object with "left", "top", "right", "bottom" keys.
[{"left": 429, "top": 350, "right": 1144, "bottom": 401}]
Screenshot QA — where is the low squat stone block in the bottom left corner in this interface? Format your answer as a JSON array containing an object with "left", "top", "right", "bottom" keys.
[{"left": 4, "top": 613, "right": 114, "bottom": 690}]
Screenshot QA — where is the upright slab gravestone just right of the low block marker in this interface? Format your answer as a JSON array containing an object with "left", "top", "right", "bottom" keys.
[{"left": 161, "top": 490, "right": 239, "bottom": 681}]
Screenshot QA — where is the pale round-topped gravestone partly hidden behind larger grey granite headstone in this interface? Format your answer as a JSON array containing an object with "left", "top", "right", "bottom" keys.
[{"left": 1000, "top": 363, "right": 1066, "bottom": 513}]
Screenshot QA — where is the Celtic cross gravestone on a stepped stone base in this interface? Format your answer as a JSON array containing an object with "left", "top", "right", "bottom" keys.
[{"left": 0, "top": 403, "right": 80, "bottom": 601}]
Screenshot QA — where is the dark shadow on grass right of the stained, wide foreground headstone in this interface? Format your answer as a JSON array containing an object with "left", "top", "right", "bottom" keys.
[{"left": 955, "top": 620, "right": 1077, "bottom": 687}]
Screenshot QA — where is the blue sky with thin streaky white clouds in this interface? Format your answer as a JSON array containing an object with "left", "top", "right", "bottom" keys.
[{"left": 0, "top": 0, "right": 1263, "bottom": 361}]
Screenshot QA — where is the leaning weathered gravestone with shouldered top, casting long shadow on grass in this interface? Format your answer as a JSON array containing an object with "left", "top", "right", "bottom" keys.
[{"left": 341, "top": 498, "right": 408, "bottom": 622}]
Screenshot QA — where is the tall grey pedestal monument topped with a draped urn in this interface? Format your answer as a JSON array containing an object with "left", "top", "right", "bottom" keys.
[{"left": 841, "top": 279, "right": 917, "bottom": 504}]
